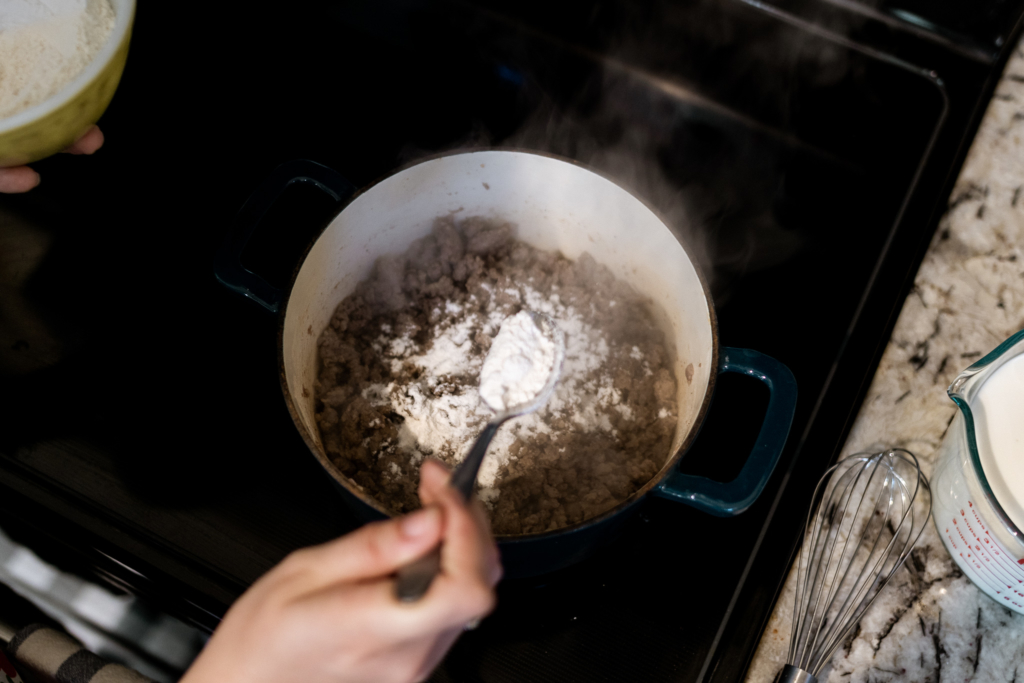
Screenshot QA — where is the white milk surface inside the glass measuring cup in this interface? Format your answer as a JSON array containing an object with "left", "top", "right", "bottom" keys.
[{"left": 971, "top": 355, "right": 1024, "bottom": 529}]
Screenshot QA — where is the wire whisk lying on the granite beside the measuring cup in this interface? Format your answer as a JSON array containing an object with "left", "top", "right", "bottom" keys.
[{"left": 776, "top": 449, "right": 932, "bottom": 683}]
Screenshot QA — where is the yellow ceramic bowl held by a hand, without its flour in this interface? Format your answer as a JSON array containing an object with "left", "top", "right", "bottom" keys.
[{"left": 0, "top": 0, "right": 135, "bottom": 168}]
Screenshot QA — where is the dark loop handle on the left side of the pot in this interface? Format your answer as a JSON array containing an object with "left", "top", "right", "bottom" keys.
[{"left": 213, "top": 159, "right": 355, "bottom": 313}]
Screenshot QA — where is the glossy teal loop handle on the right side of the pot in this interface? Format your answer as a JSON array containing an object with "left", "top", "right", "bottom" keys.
[{"left": 652, "top": 347, "right": 797, "bottom": 517}]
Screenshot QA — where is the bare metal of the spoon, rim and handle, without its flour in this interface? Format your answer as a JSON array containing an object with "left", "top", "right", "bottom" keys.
[{"left": 395, "top": 311, "right": 565, "bottom": 602}]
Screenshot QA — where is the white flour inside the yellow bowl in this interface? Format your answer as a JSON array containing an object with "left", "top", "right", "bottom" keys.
[{"left": 0, "top": 0, "right": 115, "bottom": 119}]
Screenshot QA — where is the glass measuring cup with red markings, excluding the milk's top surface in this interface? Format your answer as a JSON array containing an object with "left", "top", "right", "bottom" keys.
[{"left": 932, "top": 330, "right": 1024, "bottom": 614}]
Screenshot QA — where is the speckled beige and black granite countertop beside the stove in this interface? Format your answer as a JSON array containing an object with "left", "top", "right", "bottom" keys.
[{"left": 746, "top": 41, "right": 1024, "bottom": 683}]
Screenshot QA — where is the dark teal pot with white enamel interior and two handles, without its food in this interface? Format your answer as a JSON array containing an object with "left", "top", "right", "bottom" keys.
[{"left": 217, "top": 150, "right": 796, "bottom": 572}]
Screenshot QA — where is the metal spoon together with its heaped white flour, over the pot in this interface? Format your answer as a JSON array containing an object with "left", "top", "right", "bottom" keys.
[{"left": 395, "top": 310, "right": 565, "bottom": 602}]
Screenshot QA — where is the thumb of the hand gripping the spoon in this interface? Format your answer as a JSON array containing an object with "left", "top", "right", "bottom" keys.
[{"left": 309, "top": 506, "right": 443, "bottom": 583}]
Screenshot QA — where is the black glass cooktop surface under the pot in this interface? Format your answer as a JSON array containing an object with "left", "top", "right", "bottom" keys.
[{"left": 0, "top": 0, "right": 1020, "bottom": 682}]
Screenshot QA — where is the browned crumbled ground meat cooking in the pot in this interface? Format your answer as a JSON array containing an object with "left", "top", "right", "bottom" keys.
[{"left": 316, "top": 218, "right": 675, "bottom": 533}]
